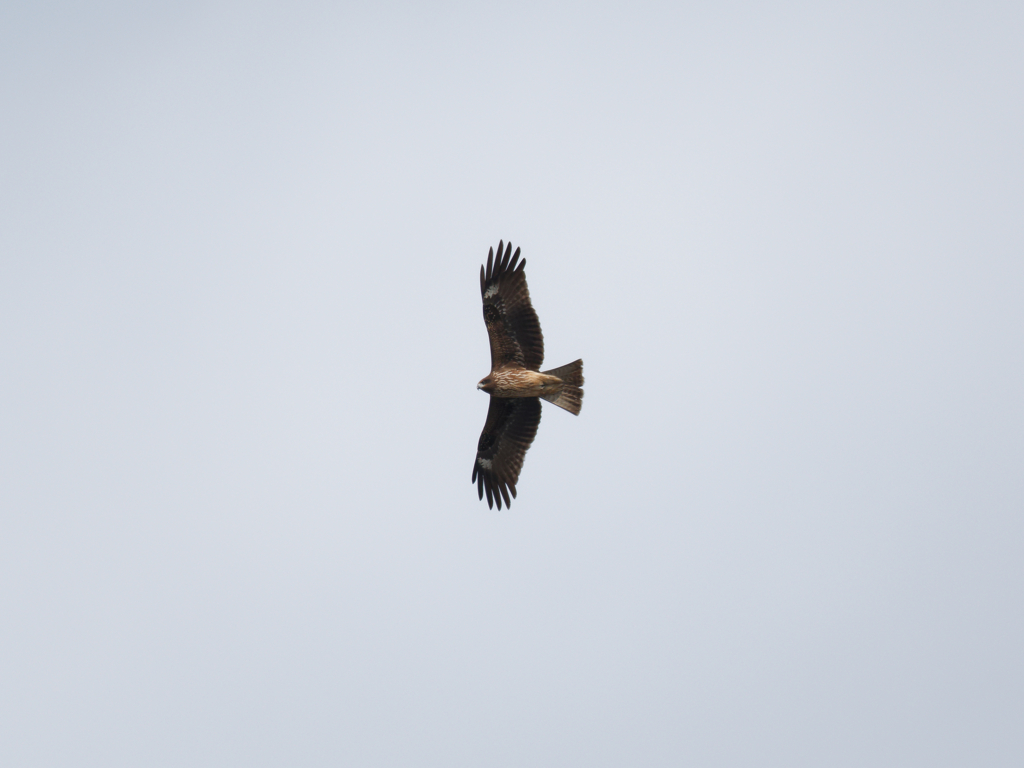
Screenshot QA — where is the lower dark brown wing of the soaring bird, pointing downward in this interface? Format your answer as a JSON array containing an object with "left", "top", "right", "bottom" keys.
[{"left": 473, "top": 396, "right": 541, "bottom": 509}]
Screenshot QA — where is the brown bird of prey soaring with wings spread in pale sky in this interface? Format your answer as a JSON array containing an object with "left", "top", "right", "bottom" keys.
[{"left": 473, "top": 242, "right": 583, "bottom": 509}]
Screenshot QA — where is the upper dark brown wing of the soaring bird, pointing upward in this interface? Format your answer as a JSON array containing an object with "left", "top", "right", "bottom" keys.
[{"left": 480, "top": 242, "right": 544, "bottom": 371}]
